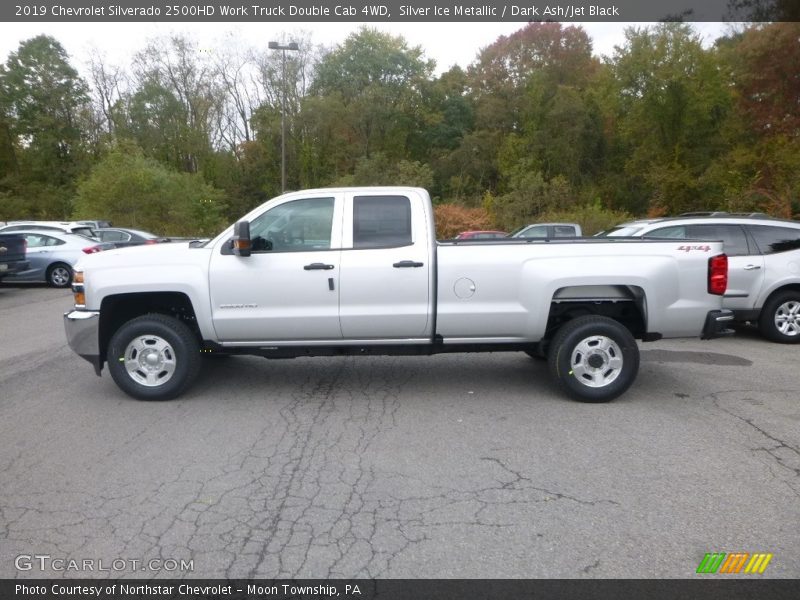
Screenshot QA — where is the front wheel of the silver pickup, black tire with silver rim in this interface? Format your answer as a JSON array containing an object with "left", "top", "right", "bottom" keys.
[{"left": 108, "top": 314, "right": 201, "bottom": 400}]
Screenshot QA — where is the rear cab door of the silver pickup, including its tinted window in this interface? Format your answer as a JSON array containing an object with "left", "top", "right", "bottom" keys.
[{"left": 339, "top": 192, "right": 433, "bottom": 340}]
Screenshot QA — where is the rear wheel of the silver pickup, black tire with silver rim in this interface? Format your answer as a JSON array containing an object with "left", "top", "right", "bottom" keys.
[{"left": 547, "top": 315, "right": 639, "bottom": 402}]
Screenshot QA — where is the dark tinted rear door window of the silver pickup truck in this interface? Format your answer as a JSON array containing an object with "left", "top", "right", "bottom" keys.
[{"left": 353, "top": 196, "right": 412, "bottom": 248}]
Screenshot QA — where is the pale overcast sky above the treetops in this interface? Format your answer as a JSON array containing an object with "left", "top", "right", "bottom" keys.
[{"left": 0, "top": 22, "right": 724, "bottom": 73}]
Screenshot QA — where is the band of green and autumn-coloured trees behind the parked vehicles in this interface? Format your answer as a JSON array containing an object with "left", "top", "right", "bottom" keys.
[{"left": 0, "top": 22, "right": 800, "bottom": 237}]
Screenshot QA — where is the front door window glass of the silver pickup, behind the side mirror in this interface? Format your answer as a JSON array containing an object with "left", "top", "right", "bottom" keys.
[{"left": 250, "top": 198, "right": 334, "bottom": 252}]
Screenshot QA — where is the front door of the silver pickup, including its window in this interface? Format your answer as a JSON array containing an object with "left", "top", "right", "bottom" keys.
[{"left": 210, "top": 194, "right": 343, "bottom": 342}]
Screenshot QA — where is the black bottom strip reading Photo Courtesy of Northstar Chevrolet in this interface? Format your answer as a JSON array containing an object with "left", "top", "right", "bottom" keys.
[{"left": 0, "top": 573, "right": 798, "bottom": 600}]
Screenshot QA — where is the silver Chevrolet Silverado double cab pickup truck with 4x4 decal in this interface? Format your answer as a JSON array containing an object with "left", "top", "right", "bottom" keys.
[{"left": 64, "top": 187, "right": 732, "bottom": 402}]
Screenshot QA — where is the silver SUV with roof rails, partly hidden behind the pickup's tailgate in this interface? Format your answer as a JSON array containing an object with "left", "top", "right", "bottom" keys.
[{"left": 602, "top": 213, "right": 800, "bottom": 344}]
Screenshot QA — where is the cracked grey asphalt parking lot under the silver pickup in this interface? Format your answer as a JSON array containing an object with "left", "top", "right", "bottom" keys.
[{"left": 0, "top": 284, "right": 800, "bottom": 578}]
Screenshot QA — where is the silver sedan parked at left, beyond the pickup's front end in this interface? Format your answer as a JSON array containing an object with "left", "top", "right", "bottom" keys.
[{"left": 3, "top": 229, "right": 114, "bottom": 288}]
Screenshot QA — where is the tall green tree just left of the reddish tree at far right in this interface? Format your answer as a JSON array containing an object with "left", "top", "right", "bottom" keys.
[{"left": 612, "top": 23, "right": 731, "bottom": 214}]
